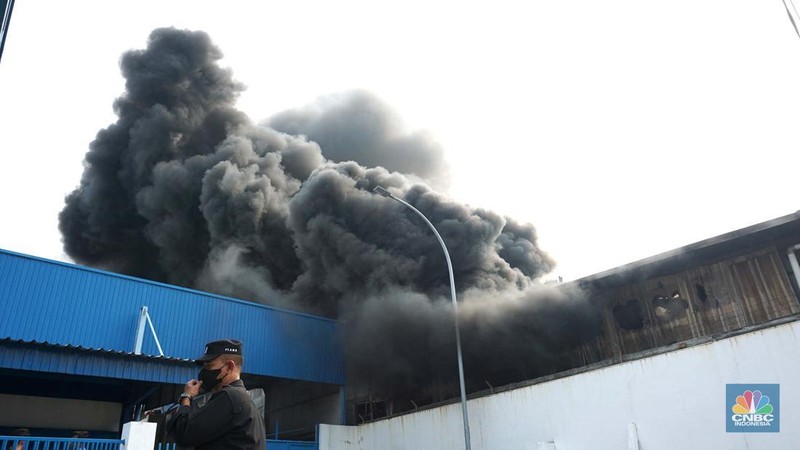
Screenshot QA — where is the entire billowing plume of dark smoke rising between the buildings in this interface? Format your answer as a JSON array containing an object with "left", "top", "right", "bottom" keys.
[{"left": 60, "top": 29, "right": 598, "bottom": 398}]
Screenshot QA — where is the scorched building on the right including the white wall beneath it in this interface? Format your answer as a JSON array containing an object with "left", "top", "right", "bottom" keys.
[{"left": 328, "top": 213, "right": 800, "bottom": 450}]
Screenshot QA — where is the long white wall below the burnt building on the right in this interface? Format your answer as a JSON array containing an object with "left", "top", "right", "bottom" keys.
[{"left": 319, "top": 322, "right": 800, "bottom": 450}]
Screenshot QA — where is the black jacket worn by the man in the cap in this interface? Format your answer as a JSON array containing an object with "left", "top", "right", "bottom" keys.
[{"left": 167, "top": 380, "right": 266, "bottom": 450}]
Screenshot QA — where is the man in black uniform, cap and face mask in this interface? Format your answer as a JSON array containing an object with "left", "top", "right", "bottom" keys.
[{"left": 167, "top": 339, "right": 266, "bottom": 450}]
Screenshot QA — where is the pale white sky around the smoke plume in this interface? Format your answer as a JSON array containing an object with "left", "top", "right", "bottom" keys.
[{"left": 0, "top": 0, "right": 800, "bottom": 280}]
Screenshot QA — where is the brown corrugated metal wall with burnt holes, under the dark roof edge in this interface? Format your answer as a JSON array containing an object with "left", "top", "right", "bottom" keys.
[{"left": 587, "top": 247, "right": 800, "bottom": 363}]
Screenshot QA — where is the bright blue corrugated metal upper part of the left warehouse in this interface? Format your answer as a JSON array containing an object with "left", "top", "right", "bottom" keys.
[{"left": 0, "top": 250, "right": 344, "bottom": 384}]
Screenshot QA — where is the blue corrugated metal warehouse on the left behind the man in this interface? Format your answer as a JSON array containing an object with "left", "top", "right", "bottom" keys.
[{"left": 0, "top": 251, "right": 344, "bottom": 439}]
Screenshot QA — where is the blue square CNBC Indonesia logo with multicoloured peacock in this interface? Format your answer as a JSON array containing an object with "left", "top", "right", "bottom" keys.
[{"left": 726, "top": 384, "right": 780, "bottom": 433}]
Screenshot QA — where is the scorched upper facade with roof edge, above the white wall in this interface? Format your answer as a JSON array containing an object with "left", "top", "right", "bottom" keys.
[{"left": 575, "top": 214, "right": 800, "bottom": 365}]
